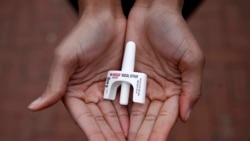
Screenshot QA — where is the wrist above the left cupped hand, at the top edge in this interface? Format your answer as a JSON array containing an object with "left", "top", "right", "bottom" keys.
[{"left": 78, "top": 0, "right": 123, "bottom": 17}]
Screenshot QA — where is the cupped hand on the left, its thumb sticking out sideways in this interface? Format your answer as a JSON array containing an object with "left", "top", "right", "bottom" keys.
[{"left": 29, "top": 0, "right": 129, "bottom": 141}]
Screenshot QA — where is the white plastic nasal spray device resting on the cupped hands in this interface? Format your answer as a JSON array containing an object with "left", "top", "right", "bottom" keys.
[{"left": 103, "top": 41, "right": 147, "bottom": 105}]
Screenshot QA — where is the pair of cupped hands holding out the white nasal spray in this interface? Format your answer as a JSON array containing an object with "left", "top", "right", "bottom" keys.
[{"left": 29, "top": 0, "right": 204, "bottom": 141}]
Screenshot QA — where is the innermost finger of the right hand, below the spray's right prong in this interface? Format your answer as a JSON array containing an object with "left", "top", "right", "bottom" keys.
[{"left": 128, "top": 99, "right": 149, "bottom": 141}]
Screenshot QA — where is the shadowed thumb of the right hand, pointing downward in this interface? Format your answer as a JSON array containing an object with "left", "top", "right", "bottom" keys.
[{"left": 179, "top": 49, "right": 204, "bottom": 121}]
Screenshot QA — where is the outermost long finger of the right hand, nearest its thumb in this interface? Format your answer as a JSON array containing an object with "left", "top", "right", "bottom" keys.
[{"left": 149, "top": 96, "right": 179, "bottom": 141}]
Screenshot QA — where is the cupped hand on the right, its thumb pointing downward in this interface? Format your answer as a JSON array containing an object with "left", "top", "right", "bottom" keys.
[{"left": 126, "top": 5, "right": 203, "bottom": 141}]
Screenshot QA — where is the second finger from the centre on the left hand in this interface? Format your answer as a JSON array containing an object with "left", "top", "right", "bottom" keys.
[{"left": 98, "top": 101, "right": 126, "bottom": 141}]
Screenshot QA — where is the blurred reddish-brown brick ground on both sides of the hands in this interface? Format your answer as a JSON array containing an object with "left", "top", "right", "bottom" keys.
[{"left": 0, "top": 0, "right": 250, "bottom": 141}]
